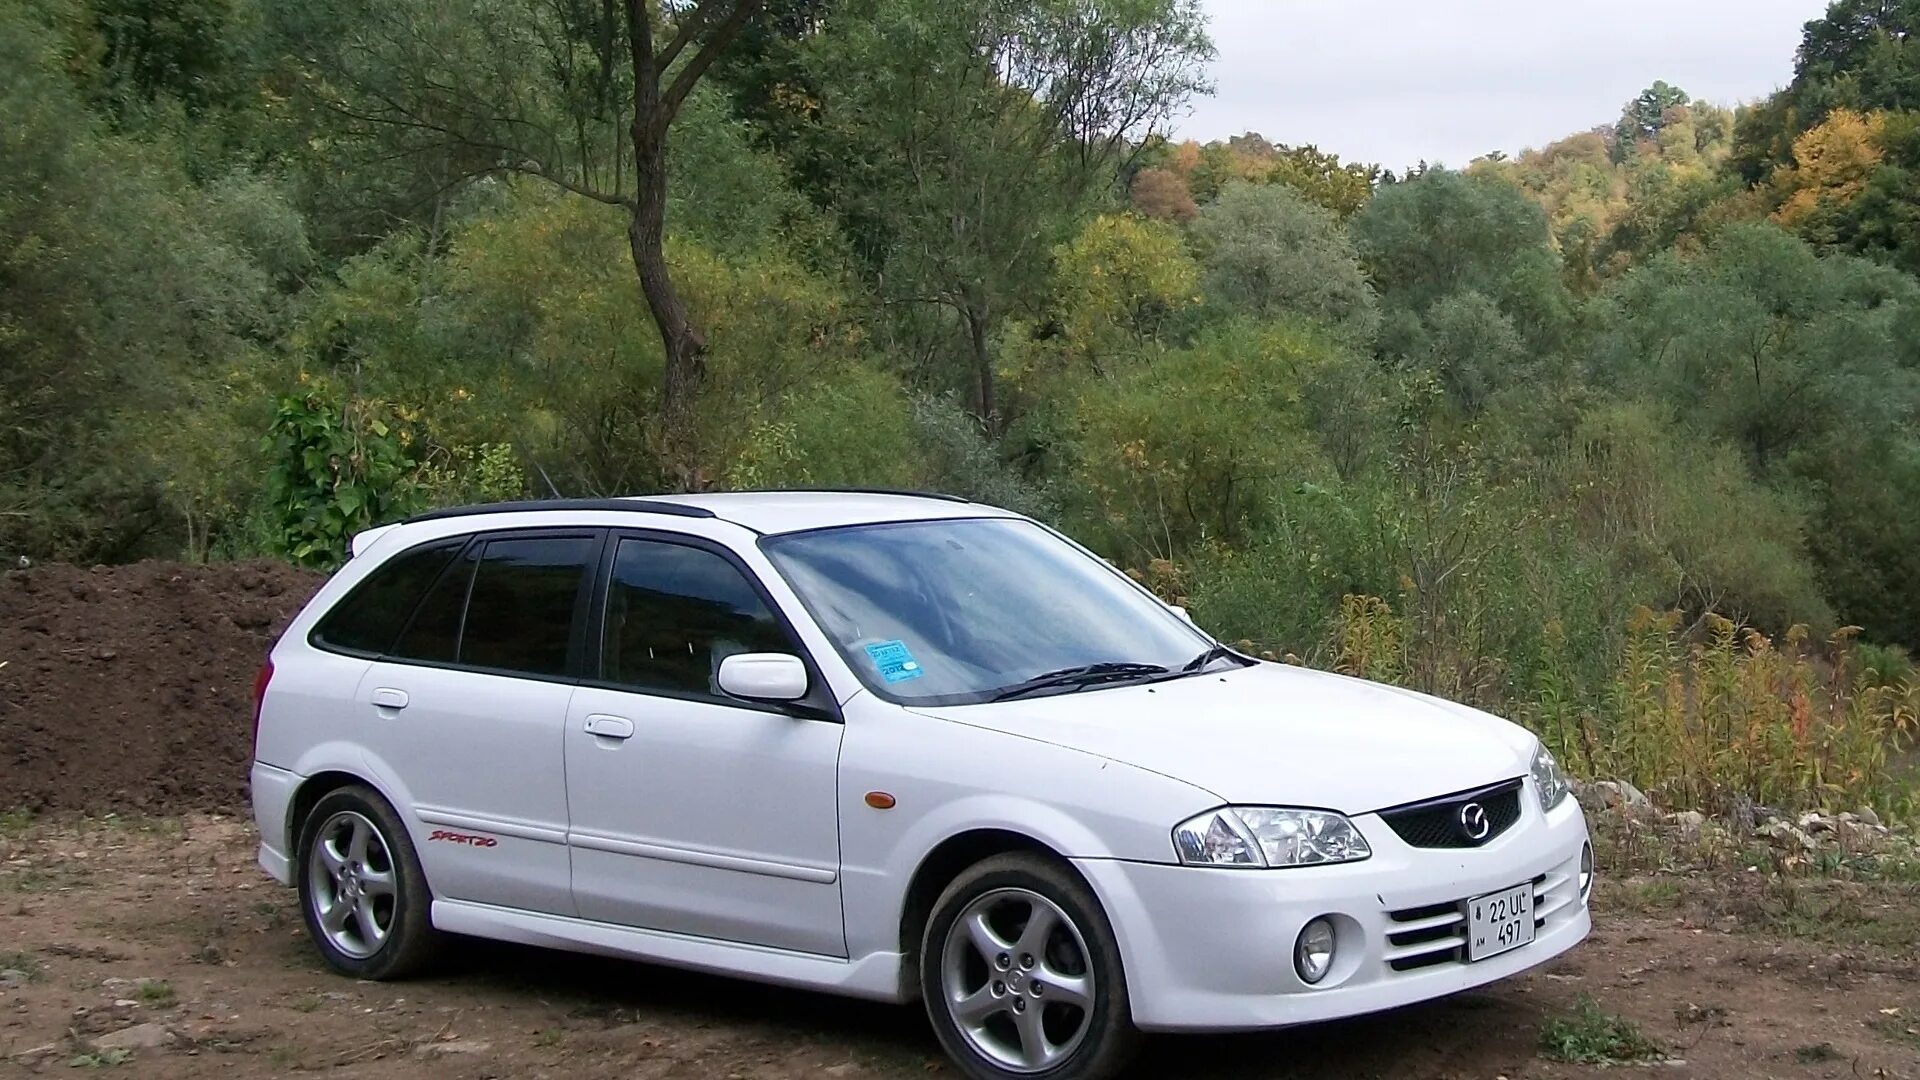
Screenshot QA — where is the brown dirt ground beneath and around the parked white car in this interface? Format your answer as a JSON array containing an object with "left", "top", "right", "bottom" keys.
[{"left": 0, "top": 815, "right": 1920, "bottom": 1080}]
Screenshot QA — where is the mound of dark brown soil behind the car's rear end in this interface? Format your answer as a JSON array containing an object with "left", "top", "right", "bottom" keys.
[{"left": 0, "top": 561, "right": 324, "bottom": 815}]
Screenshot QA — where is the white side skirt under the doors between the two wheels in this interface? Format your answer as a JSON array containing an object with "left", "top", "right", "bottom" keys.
[{"left": 432, "top": 899, "right": 912, "bottom": 1003}]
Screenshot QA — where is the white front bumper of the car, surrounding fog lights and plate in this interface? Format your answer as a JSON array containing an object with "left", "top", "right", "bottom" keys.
[{"left": 1075, "top": 786, "right": 1592, "bottom": 1032}]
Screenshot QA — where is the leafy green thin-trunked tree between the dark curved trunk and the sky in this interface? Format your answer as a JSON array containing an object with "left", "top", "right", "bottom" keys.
[{"left": 812, "top": 0, "right": 1212, "bottom": 423}]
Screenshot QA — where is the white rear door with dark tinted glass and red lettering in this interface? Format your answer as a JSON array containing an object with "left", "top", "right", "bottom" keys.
[{"left": 355, "top": 528, "right": 601, "bottom": 915}]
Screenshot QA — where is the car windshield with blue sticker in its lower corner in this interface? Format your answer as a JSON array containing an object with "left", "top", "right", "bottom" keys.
[{"left": 762, "top": 519, "right": 1219, "bottom": 705}]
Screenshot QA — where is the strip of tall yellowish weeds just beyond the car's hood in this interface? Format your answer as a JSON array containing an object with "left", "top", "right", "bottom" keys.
[{"left": 1331, "top": 596, "right": 1920, "bottom": 815}]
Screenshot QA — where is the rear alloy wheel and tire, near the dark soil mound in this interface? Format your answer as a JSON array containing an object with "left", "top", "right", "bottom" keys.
[{"left": 296, "top": 784, "right": 442, "bottom": 980}]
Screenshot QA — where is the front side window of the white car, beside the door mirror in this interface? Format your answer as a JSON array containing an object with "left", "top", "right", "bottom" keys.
[{"left": 601, "top": 538, "right": 801, "bottom": 698}]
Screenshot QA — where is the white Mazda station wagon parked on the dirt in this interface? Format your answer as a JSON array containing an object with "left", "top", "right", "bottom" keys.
[{"left": 252, "top": 492, "right": 1594, "bottom": 1078}]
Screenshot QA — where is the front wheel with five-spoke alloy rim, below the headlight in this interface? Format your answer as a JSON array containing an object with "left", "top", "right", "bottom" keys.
[{"left": 920, "top": 853, "right": 1139, "bottom": 1080}]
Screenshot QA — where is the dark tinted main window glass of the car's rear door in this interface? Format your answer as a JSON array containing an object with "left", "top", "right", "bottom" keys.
[{"left": 459, "top": 536, "right": 595, "bottom": 675}]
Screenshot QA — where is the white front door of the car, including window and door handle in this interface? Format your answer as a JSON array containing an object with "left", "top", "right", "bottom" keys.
[{"left": 566, "top": 534, "right": 847, "bottom": 955}]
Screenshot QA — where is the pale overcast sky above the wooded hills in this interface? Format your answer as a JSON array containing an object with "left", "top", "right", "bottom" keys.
[{"left": 1175, "top": 0, "right": 1826, "bottom": 169}]
